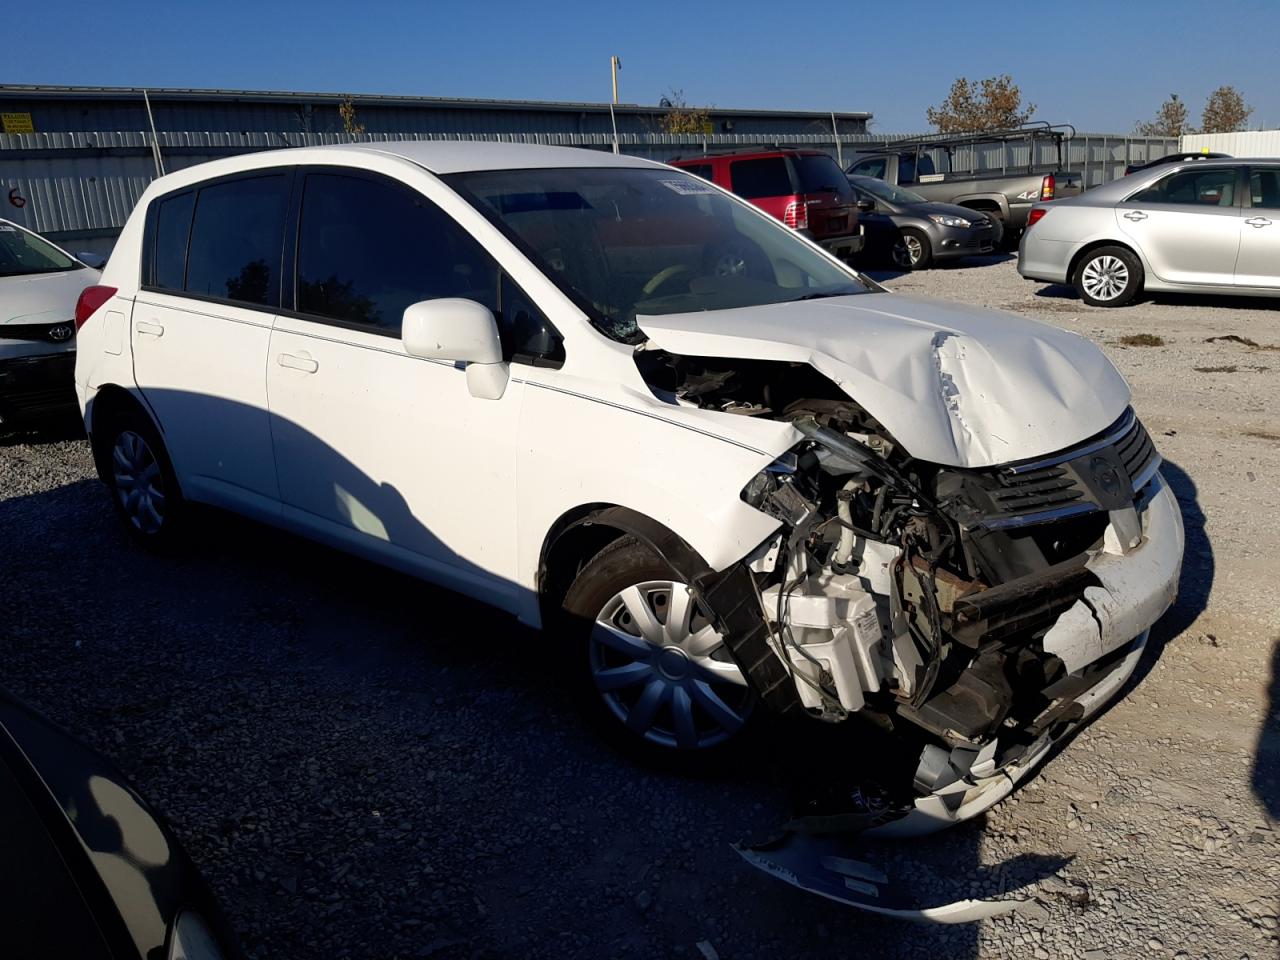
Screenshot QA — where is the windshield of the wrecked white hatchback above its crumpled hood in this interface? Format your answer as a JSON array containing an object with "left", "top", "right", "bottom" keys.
[{"left": 444, "top": 168, "right": 876, "bottom": 343}]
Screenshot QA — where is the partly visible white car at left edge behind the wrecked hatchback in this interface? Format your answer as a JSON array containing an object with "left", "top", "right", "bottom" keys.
[{"left": 0, "top": 220, "right": 101, "bottom": 428}]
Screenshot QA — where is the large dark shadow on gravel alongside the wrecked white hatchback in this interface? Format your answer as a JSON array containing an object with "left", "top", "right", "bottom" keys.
[{"left": 0, "top": 430, "right": 1064, "bottom": 960}]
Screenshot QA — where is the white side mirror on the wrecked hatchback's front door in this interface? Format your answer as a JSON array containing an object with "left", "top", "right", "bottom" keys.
[{"left": 401, "top": 298, "right": 507, "bottom": 399}]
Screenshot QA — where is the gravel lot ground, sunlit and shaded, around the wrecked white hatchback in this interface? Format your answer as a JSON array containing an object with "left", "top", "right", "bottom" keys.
[{"left": 0, "top": 257, "right": 1280, "bottom": 960}]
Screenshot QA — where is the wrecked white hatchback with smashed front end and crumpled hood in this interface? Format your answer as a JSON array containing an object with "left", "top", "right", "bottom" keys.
[{"left": 76, "top": 142, "right": 1183, "bottom": 832}]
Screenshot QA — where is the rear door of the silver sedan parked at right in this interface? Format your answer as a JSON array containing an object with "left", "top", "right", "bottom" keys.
[{"left": 1115, "top": 166, "right": 1243, "bottom": 287}]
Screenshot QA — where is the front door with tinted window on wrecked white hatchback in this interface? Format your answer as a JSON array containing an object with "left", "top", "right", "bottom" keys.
[{"left": 266, "top": 168, "right": 524, "bottom": 605}]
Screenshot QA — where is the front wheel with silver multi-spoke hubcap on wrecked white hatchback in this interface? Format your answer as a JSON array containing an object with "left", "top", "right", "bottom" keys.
[{"left": 564, "top": 538, "right": 755, "bottom": 763}]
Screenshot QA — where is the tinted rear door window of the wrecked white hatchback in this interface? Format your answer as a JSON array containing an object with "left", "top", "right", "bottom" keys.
[{"left": 184, "top": 175, "right": 289, "bottom": 306}]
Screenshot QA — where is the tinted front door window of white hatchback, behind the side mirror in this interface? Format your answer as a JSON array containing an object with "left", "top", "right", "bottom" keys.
[{"left": 298, "top": 174, "right": 498, "bottom": 333}]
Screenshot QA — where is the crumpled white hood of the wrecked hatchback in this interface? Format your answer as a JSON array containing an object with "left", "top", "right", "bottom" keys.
[{"left": 636, "top": 293, "right": 1129, "bottom": 467}]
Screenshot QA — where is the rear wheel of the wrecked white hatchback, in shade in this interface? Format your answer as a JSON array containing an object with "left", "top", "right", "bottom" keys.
[{"left": 93, "top": 410, "right": 191, "bottom": 554}]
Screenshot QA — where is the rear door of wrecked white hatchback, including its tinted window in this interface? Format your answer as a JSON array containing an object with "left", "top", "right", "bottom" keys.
[{"left": 131, "top": 175, "right": 293, "bottom": 513}]
